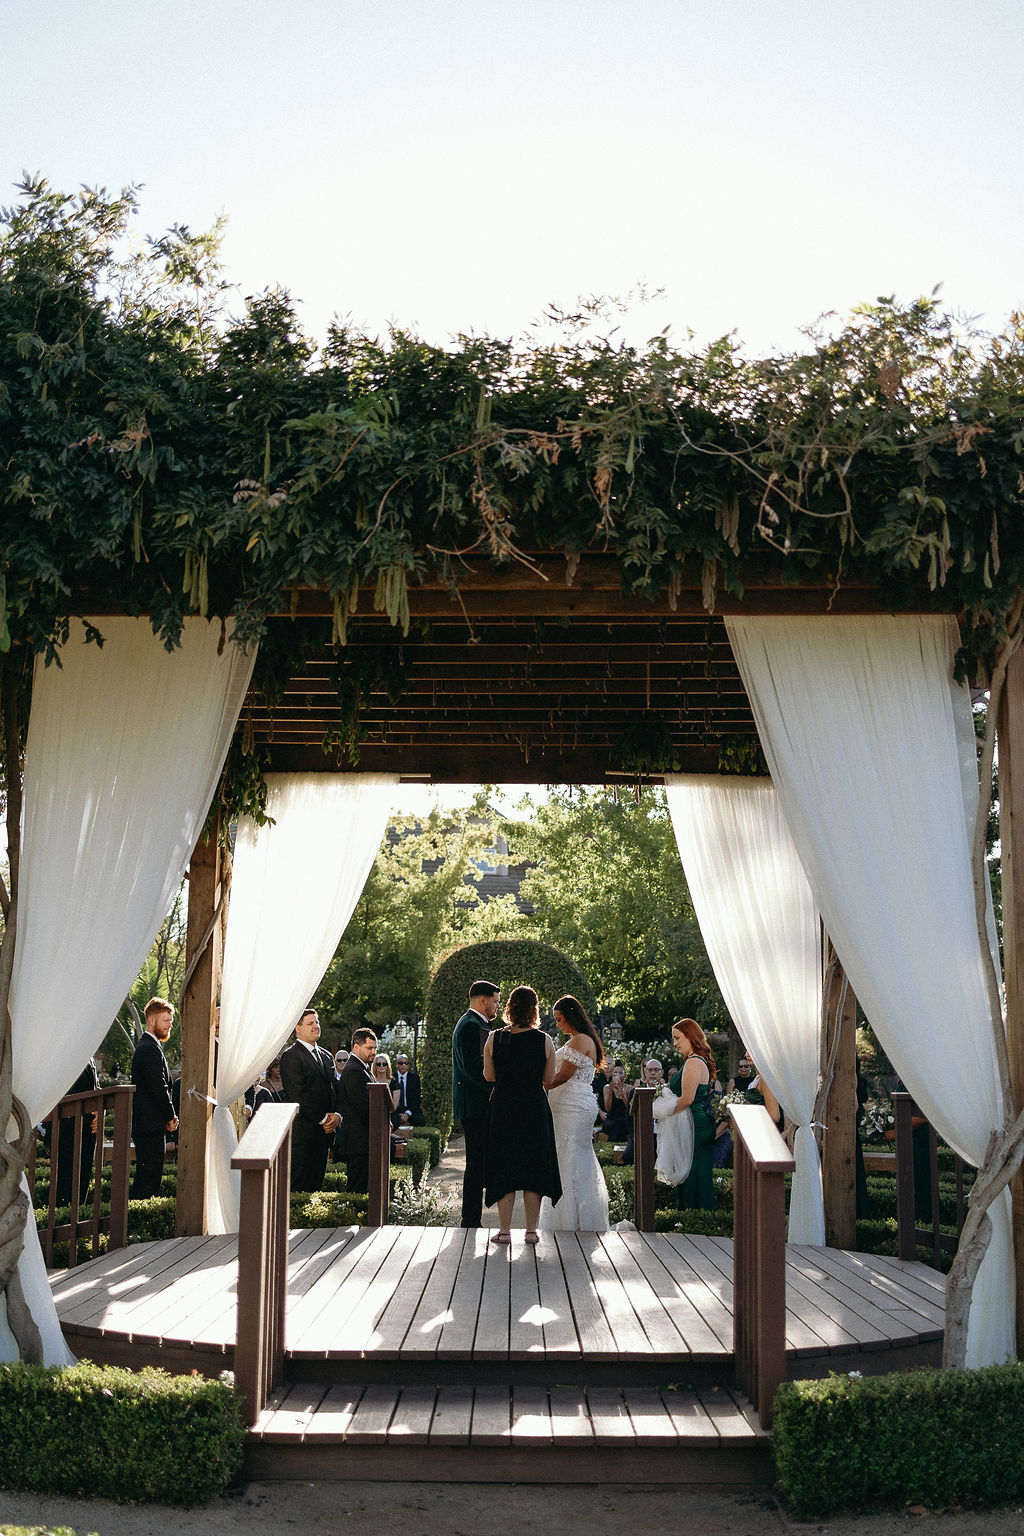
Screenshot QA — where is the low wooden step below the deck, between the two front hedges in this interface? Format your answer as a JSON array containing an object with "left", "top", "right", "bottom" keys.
[{"left": 246, "top": 1382, "right": 772, "bottom": 1487}]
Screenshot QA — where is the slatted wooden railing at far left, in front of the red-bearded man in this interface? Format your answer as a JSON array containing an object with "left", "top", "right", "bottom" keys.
[{"left": 28, "top": 1083, "right": 135, "bottom": 1267}]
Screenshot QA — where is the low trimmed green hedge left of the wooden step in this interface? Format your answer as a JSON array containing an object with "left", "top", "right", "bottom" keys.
[{"left": 0, "top": 1361, "right": 246, "bottom": 1504}]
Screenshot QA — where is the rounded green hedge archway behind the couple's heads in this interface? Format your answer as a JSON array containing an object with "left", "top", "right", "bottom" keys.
[{"left": 422, "top": 938, "right": 597, "bottom": 1140}]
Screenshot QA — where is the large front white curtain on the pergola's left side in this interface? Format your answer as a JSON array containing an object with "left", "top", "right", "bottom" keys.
[{"left": 0, "top": 617, "right": 255, "bottom": 1364}]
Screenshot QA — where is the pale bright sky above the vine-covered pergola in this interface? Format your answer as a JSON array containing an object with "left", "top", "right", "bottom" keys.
[{"left": 0, "top": 0, "right": 1024, "bottom": 350}]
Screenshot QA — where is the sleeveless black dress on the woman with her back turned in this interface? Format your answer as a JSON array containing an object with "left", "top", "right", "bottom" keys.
[{"left": 485, "top": 1029, "right": 562, "bottom": 1206}]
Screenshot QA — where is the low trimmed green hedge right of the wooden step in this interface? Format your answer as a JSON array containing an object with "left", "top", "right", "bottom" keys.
[{"left": 772, "top": 1361, "right": 1024, "bottom": 1519}]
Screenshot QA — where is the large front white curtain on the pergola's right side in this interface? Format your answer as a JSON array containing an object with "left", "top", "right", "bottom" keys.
[{"left": 726, "top": 616, "right": 1015, "bottom": 1367}]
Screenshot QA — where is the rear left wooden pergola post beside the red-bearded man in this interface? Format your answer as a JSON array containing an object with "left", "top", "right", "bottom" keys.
[{"left": 175, "top": 816, "right": 221, "bottom": 1238}]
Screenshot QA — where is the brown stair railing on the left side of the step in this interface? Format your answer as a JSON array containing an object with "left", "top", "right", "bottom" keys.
[{"left": 232, "top": 1104, "right": 299, "bottom": 1424}]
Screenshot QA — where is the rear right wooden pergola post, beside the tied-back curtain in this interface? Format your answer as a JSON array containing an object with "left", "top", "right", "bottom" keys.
[{"left": 821, "top": 945, "right": 857, "bottom": 1249}]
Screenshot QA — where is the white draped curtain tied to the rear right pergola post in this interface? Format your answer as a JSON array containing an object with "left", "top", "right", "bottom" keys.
[{"left": 665, "top": 774, "right": 824, "bottom": 1244}]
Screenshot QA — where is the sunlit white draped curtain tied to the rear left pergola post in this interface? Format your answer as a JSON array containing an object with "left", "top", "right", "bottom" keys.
[{"left": 205, "top": 773, "right": 398, "bottom": 1232}]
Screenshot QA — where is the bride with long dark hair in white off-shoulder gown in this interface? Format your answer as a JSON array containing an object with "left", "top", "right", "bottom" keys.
[{"left": 540, "top": 997, "right": 608, "bottom": 1232}]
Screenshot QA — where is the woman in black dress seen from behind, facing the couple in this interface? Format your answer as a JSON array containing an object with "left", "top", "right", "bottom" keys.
[{"left": 484, "top": 986, "right": 562, "bottom": 1243}]
